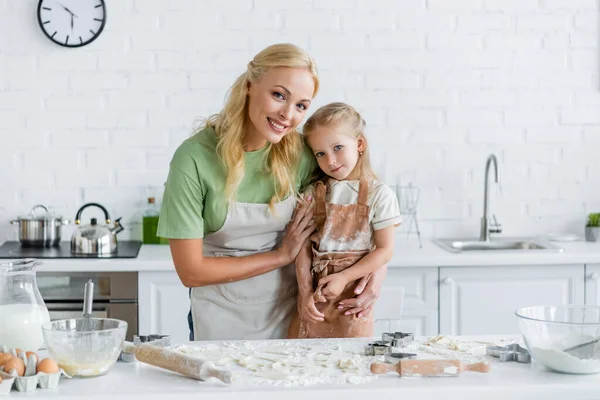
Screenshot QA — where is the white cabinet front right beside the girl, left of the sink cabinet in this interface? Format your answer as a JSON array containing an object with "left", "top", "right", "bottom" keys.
[{"left": 374, "top": 267, "right": 438, "bottom": 336}]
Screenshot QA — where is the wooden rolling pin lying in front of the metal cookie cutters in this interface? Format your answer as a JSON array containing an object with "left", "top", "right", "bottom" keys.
[{"left": 371, "top": 359, "right": 490, "bottom": 377}]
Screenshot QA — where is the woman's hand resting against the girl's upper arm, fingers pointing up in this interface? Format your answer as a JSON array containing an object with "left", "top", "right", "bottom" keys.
[{"left": 277, "top": 196, "right": 316, "bottom": 265}]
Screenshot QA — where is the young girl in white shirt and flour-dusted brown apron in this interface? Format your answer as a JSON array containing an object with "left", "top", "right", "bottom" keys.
[{"left": 288, "top": 103, "right": 402, "bottom": 338}]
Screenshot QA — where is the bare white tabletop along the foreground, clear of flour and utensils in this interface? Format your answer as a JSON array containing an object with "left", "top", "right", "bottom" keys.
[{"left": 10, "top": 336, "right": 600, "bottom": 400}]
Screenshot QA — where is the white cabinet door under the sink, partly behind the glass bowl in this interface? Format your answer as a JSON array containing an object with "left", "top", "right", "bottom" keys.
[{"left": 439, "top": 265, "right": 585, "bottom": 335}]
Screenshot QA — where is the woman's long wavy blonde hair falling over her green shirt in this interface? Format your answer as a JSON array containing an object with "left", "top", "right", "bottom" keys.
[{"left": 206, "top": 43, "right": 319, "bottom": 209}]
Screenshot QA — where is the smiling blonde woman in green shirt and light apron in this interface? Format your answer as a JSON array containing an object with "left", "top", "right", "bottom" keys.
[{"left": 158, "top": 44, "right": 385, "bottom": 340}]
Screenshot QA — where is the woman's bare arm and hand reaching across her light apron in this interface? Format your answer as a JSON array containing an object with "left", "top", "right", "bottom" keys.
[{"left": 169, "top": 205, "right": 315, "bottom": 287}]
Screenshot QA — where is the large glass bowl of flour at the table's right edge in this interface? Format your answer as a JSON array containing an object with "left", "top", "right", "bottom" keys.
[{"left": 515, "top": 305, "right": 600, "bottom": 374}]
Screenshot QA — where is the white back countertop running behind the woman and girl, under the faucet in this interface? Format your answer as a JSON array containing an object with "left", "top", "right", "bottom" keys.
[{"left": 8, "top": 238, "right": 600, "bottom": 272}]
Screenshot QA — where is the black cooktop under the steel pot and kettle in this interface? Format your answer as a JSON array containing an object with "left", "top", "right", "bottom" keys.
[{"left": 0, "top": 240, "right": 142, "bottom": 258}]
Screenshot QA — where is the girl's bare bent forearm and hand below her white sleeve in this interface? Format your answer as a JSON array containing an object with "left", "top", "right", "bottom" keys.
[{"left": 319, "top": 226, "right": 395, "bottom": 297}]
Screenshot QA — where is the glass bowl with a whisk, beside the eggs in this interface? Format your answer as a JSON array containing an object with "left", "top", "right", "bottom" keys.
[{"left": 42, "top": 318, "right": 127, "bottom": 377}]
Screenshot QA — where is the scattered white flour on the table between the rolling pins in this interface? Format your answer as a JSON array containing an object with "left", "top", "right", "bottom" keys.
[{"left": 176, "top": 335, "right": 492, "bottom": 387}]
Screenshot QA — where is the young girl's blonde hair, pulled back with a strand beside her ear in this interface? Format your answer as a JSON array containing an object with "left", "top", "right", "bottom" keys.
[{"left": 302, "top": 102, "right": 379, "bottom": 179}]
